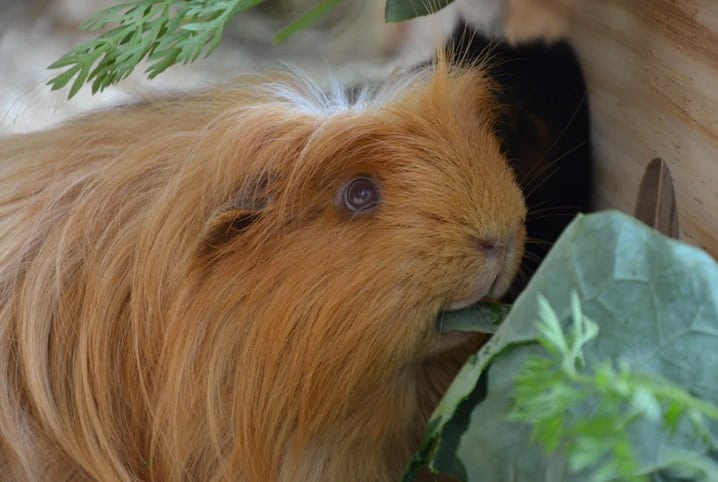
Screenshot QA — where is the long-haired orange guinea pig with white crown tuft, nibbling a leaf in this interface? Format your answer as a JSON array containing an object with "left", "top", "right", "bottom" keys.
[{"left": 0, "top": 61, "right": 526, "bottom": 482}]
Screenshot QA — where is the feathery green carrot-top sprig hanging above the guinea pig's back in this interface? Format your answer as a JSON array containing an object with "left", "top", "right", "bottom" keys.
[{"left": 48, "top": 0, "right": 264, "bottom": 98}]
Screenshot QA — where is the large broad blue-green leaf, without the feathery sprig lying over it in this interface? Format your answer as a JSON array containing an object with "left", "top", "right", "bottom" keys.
[{"left": 407, "top": 212, "right": 718, "bottom": 482}]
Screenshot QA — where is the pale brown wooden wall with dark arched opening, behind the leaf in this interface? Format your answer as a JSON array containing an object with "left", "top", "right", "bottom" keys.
[{"left": 506, "top": 0, "right": 718, "bottom": 258}]
